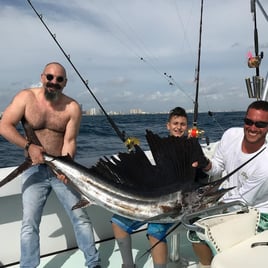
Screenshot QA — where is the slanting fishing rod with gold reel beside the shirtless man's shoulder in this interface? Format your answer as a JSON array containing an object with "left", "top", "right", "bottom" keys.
[{"left": 27, "top": 0, "right": 139, "bottom": 150}]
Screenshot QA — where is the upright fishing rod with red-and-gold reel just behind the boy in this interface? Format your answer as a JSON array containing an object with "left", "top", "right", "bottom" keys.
[{"left": 188, "top": 0, "right": 204, "bottom": 138}]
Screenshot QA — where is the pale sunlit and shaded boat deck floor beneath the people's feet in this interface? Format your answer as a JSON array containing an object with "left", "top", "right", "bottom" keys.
[{"left": 2, "top": 226, "right": 197, "bottom": 268}]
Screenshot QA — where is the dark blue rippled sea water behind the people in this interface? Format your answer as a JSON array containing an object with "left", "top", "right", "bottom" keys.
[{"left": 0, "top": 112, "right": 245, "bottom": 167}]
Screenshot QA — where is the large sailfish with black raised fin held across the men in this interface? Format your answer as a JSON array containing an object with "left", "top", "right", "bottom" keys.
[{"left": 0, "top": 118, "right": 234, "bottom": 223}]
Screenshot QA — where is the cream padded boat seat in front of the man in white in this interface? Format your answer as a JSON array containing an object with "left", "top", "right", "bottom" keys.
[{"left": 181, "top": 202, "right": 268, "bottom": 268}]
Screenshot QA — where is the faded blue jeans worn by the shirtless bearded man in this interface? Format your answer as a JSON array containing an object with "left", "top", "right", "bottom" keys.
[{"left": 20, "top": 165, "right": 100, "bottom": 268}]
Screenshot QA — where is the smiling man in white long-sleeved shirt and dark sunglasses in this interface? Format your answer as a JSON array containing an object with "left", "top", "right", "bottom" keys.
[{"left": 193, "top": 101, "right": 268, "bottom": 268}]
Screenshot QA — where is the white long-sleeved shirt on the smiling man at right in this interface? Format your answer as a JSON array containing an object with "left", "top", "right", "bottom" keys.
[{"left": 208, "top": 128, "right": 268, "bottom": 213}]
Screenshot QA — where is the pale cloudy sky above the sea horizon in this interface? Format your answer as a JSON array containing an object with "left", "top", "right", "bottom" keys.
[{"left": 0, "top": 0, "right": 268, "bottom": 112}]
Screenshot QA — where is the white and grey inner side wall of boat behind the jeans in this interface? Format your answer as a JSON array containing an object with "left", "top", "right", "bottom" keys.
[{"left": 0, "top": 165, "right": 113, "bottom": 265}]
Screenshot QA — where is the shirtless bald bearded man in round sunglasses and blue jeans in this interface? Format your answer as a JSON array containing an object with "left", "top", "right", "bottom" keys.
[{"left": 0, "top": 62, "right": 100, "bottom": 268}]
